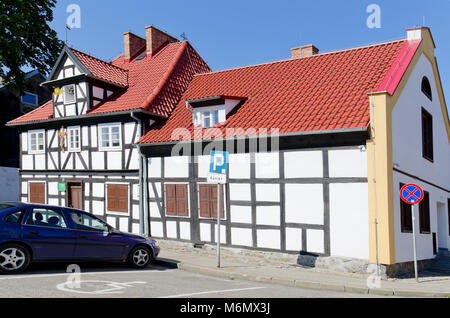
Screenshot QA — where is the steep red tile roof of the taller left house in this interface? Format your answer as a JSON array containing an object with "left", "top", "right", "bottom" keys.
[{"left": 9, "top": 42, "right": 211, "bottom": 124}]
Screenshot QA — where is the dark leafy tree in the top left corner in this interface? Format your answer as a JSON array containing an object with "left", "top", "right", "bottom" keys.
[{"left": 0, "top": 0, "right": 63, "bottom": 93}]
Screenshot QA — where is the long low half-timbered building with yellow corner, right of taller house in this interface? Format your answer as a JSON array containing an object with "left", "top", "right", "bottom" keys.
[{"left": 140, "top": 28, "right": 450, "bottom": 273}]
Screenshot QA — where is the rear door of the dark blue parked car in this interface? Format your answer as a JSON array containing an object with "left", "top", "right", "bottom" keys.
[{"left": 22, "top": 206, "right": 76, "bottom": 260}]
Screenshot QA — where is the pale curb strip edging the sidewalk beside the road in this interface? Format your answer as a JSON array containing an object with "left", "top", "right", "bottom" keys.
[{"left": 154, "top": 258, "right": 450, "bottom": 297}]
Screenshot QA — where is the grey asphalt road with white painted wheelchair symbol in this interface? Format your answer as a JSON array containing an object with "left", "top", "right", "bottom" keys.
[{"left": 0, "top": 263, "right": 394, "bottom": 298}]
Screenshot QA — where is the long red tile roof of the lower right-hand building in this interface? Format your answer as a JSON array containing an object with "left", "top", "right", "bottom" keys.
[{"left": 140, "top": 40, "right": 418, "bottom": 143}]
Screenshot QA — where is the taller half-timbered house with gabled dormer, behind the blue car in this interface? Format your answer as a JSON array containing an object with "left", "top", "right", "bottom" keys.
[{"left": 9, "top": 26, "right": 210, "bottom": 233}]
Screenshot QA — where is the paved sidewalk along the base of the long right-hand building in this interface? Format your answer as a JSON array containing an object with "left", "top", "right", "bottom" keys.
[{"left": 154, "top": 241, "right": 450, "bottom": 297}]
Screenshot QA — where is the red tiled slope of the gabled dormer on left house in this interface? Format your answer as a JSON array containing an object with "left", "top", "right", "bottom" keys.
[{"left": 69, "top": 48, "right": 128, "bottom": 87}]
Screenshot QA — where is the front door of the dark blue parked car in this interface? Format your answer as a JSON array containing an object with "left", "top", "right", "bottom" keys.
[{"left": 68, "top": 210, "right": 126, "bottom": 259}]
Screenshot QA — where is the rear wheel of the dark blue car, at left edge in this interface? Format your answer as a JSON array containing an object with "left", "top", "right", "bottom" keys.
[{"left": 0, "top": 244, "right": 31, "bottom": 274}]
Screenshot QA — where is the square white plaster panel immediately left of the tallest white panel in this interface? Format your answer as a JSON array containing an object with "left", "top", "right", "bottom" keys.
[{"left": 285, "top": 184, "right": 324, "bottom": 224}]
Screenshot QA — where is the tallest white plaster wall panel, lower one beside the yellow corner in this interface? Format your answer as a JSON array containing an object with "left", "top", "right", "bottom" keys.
[{"left": 330, "top": 183, "right": 369, "bottom": 259}]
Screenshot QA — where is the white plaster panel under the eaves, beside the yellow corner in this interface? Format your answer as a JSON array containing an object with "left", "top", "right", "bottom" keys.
[{"left": 328, "top": 148, "right": 367, "bottom": 178}]
